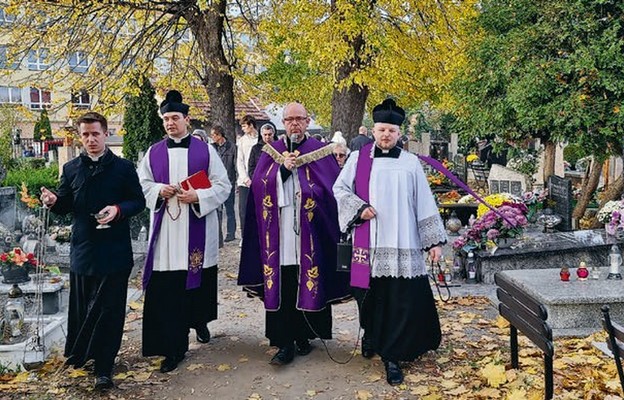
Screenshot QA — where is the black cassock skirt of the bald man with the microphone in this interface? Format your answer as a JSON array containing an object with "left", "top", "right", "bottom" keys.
[{"left": 266, "top": 265, "right": 332, "bottom": 347}]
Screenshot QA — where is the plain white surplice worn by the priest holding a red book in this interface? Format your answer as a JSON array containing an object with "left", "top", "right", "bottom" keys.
[{"left": 138, "top": 138, "right": 232, "bottom": 271}]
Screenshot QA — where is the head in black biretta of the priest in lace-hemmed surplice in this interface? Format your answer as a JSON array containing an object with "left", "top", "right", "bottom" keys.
[{"left": 373, "top": 99, "right": 405, "bottom": 150}]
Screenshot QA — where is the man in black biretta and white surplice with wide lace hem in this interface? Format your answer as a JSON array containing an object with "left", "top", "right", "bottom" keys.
[{"left": 333, "top": 99, "right": 447, "bottom": 384}]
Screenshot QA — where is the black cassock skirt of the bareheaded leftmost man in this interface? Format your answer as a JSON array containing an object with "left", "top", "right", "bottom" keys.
[{"left": 65, "top": 271, "right": 130, "bottom": 376}]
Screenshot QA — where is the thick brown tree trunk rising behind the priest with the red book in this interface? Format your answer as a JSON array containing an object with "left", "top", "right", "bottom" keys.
[{"left": 185, "top": 1, "right": 236, "bottom": 143}]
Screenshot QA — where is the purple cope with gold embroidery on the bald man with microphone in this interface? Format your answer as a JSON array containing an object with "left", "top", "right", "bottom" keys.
[{"left": 238, "top": 138, "right": 349, "bottom": 311}]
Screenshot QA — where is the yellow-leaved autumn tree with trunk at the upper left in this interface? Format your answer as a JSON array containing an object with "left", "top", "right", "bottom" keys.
[{"left": 0, "top": 0, "right": 244, "bottom": 141}]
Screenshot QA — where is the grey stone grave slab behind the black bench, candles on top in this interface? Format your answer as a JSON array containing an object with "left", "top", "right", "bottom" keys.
[{"left": 497, "top": 267, "right": 624, "bottom": 336}]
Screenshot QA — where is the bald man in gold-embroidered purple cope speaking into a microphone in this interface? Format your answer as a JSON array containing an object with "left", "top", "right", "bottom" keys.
[{"left": 238, "top": 103, "right": 350, "bottom": 365}]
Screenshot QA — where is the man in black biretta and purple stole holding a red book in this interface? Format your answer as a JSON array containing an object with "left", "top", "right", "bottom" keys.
[{"left": 138, "top": 90, "right": 231, "bottom": 372}]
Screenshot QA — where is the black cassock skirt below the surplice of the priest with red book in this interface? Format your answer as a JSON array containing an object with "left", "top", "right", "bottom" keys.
[{"left": 142, "top": 266, "right": 217, "bottom": 356}]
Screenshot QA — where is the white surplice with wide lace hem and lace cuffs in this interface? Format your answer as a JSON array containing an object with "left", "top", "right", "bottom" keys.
[{"left": 333, "top": 146, "right": 447, "bottom": 278}]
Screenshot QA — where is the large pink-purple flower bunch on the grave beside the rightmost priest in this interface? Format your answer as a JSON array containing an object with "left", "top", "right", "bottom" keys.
[{"left": 453, "top": 202, "right": 528, "bottom": 250}]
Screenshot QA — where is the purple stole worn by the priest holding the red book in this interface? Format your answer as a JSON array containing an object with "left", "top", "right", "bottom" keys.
[{"left": 143, "top": 137, "right": 210, "bottom": 290}]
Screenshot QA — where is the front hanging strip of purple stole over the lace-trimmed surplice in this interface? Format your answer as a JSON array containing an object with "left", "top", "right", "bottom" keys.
[{"left": 351, "top": 143, "right": 374, "bottom": 289}]
